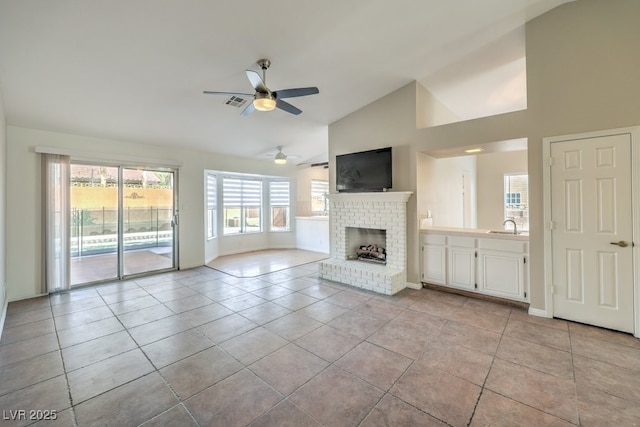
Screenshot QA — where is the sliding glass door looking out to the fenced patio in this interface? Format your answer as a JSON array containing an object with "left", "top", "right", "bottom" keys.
[{"left": 69, "top": 163, "right": 176, "bottom": 286}]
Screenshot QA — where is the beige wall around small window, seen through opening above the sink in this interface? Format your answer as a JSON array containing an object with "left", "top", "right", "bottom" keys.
[{"left": 476, "top": 151, "right": 528, "bottom": 230}]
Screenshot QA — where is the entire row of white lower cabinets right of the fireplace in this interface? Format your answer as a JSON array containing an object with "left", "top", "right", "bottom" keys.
[{"left": 422, "top": 234, "right": 529, "bottom": 301}]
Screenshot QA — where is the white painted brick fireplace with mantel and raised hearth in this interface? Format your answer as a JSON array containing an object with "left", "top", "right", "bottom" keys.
[{"left": 320, "top": 191, "right": 412, "bottom": 295}]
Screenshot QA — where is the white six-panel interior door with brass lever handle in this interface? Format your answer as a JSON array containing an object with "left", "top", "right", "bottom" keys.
[{"left": 551, "top": 134, "right": 634, "bottom": 332}]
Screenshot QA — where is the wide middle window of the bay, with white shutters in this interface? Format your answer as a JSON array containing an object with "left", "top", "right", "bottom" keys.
[{"left": 222, "top": 177, "right": 262, "bottom": 235}]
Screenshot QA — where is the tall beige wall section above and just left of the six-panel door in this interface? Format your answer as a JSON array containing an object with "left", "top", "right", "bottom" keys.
[{"left": 526, "top": 0, "right": 640, "bottom": 309}]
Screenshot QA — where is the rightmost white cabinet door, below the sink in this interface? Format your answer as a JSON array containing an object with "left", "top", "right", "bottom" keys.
[{"left": 478, "top": 251, "right": 525, "bottom": 301}]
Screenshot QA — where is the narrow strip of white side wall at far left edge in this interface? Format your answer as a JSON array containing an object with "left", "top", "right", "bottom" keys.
[{"left": 0, "top": 84, "right": 7, "bottom": 335}]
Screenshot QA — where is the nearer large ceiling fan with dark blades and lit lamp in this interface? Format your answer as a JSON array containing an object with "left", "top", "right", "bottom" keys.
[{"left": 204, "top": 59, "right": 320, "bottom": 116}]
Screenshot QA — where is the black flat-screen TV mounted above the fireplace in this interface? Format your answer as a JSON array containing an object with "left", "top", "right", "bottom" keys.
[{"left": 336, "top": 147, "right": 392, "bottom": 192}]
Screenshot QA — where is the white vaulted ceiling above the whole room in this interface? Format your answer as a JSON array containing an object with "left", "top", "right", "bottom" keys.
[{"left": 0, "top": 0, "right": 568, "bottom": 166}]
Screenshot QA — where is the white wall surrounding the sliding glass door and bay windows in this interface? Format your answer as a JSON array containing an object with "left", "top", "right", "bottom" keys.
[{"left": 3, "top": 126, "right": 295, "bottom": 301}]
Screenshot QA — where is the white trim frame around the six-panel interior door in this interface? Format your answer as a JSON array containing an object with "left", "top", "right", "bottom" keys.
[{"left": 544, "top": 126, "right": 640, "bottom": 338}]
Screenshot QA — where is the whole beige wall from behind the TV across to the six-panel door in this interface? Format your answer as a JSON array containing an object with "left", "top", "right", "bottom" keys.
[{"left": 329, "top": 0, "right": 640, "bottom": 310}]
